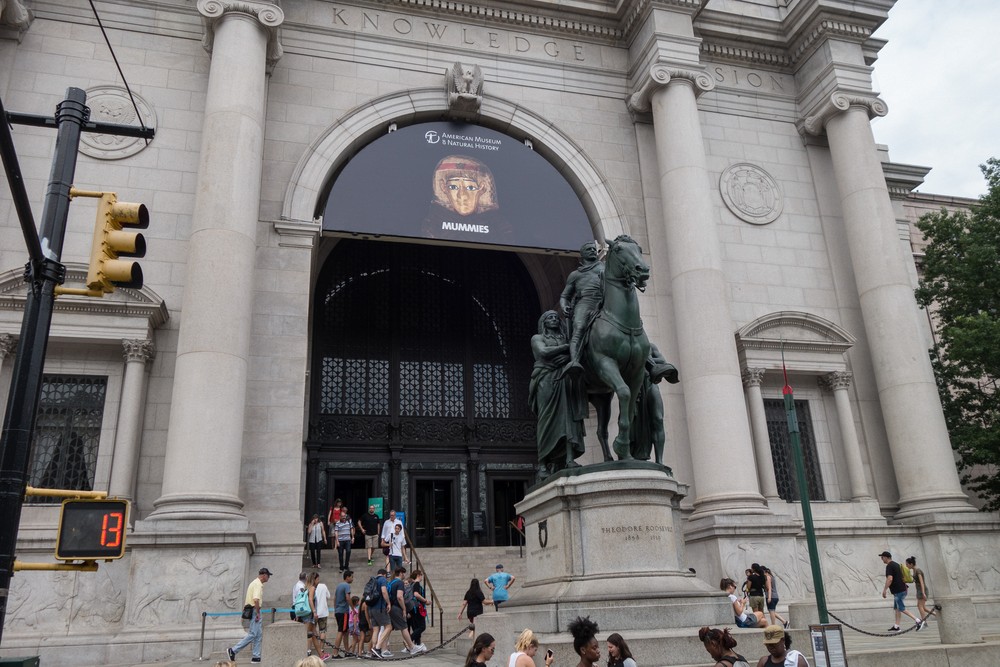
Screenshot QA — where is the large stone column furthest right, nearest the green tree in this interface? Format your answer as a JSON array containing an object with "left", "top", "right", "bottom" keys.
[{"left": 803, "top": 92, "right": 975, "bottom": 518}]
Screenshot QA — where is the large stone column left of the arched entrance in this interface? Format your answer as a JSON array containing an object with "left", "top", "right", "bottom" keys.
[{"left": 150, "top": 0, "right": 284, "bottom": 525}]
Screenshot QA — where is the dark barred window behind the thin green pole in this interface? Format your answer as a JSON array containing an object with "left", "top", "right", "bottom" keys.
[{"left": 764, "top": 398, "right": 826, "bottom": 502}]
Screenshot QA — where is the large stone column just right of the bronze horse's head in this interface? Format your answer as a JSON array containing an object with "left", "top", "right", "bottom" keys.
[{"left": 629, "top": 64, "right": 767, "bottom": 517}]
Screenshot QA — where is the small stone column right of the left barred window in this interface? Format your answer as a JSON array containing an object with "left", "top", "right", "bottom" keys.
[{"left": 108, "top": 340, "right": 156, "bottom": 499}]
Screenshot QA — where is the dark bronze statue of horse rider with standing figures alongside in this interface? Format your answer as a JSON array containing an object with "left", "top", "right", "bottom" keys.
[{"left": 529, "top": 235, "right": 678, "bottom": 479}]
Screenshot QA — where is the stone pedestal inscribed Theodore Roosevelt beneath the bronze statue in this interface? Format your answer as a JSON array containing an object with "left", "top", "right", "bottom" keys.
[{"left": 504, "top": 462, "right": 732, "bottom": 633}]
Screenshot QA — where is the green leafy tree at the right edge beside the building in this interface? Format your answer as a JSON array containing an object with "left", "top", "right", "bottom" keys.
[{"left": 916, "top": 158, "right": 1000, "bottom": 510}]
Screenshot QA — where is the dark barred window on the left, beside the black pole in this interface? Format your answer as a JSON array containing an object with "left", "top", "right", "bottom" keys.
[{"left": 28, "top": 374, "right": 108, "bottom": 502}]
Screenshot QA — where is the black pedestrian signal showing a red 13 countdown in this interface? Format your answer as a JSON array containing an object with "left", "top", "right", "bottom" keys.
[{"left": 56, "top": 500, "right": 128, "bottom": 560}]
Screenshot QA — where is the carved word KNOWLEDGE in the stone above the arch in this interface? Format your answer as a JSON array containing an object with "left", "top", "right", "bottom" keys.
[{"left": 327, "top": 7, "right": 586, "bottom": 62}]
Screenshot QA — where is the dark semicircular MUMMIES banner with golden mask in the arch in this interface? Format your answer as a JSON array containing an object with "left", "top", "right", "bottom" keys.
[{"left": 323, "top": 122, "right": 593, "bottom": 251}]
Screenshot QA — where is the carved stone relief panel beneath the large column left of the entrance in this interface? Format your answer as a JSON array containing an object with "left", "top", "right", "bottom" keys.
[{"left": 128, "top": 551, "right": 244, "bottom": 626}]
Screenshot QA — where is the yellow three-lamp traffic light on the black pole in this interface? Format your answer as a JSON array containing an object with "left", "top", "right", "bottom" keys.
[{"left": 70, "top": 188, "right": 149, "bottom": 294}]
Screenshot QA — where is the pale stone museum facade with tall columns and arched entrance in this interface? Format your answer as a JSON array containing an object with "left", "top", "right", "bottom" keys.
[{"left": 0, "top": 0, "right": 1000, "bottom": 664}]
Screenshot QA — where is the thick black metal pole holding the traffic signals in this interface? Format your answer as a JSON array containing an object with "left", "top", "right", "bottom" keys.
[{"left": 0, "top": 88, "right": 90, "bottom": 641}]
